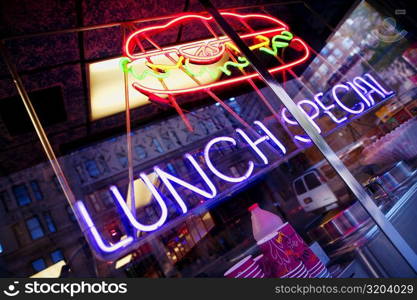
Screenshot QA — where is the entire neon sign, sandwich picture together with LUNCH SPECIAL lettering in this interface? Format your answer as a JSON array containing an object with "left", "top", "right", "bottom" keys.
[{"left": 74, "top": 13, "right": 394, "bottom": 259}]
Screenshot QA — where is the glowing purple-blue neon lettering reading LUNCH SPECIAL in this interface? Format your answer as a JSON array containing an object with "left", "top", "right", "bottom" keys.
[{"left": 75, "top": 74, "right": 394, "bottom": 258}]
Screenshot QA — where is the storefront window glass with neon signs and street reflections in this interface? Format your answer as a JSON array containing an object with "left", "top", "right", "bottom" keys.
[{"left": 0, "top": 1, "right": 417, "bottom": 277}]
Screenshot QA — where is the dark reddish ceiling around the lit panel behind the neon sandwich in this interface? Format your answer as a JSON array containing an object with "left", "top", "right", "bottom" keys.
[{"left": 0, "top": 0, "right": 353, "bottom": 176}]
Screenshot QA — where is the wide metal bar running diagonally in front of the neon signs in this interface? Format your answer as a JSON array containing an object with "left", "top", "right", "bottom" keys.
[{"left": 199, "top": 0, "right": 417, "bottom": 273}]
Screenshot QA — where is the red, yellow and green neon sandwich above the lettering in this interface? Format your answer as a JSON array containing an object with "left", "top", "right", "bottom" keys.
[{"left": 120, "top": 12, "right": 310, "bottom": 95}]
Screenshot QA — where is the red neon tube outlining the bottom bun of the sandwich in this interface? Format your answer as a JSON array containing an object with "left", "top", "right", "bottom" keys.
[{"left": 132, "top": 38, "right": 310, "bottom": 95}]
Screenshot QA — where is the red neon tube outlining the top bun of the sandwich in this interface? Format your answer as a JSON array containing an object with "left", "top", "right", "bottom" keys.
[{"left": 123, "top": 12, "right": 289, "bottom": 59}]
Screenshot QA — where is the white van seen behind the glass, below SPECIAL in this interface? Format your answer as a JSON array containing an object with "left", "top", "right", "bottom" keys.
[{"left": 293, "top": 169, "right": 338, "bottom": 212}]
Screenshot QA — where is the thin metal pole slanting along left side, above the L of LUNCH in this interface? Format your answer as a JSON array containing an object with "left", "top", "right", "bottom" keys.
[{"left": 0, "top": 42, "right": 76, "bottom": 207}]
